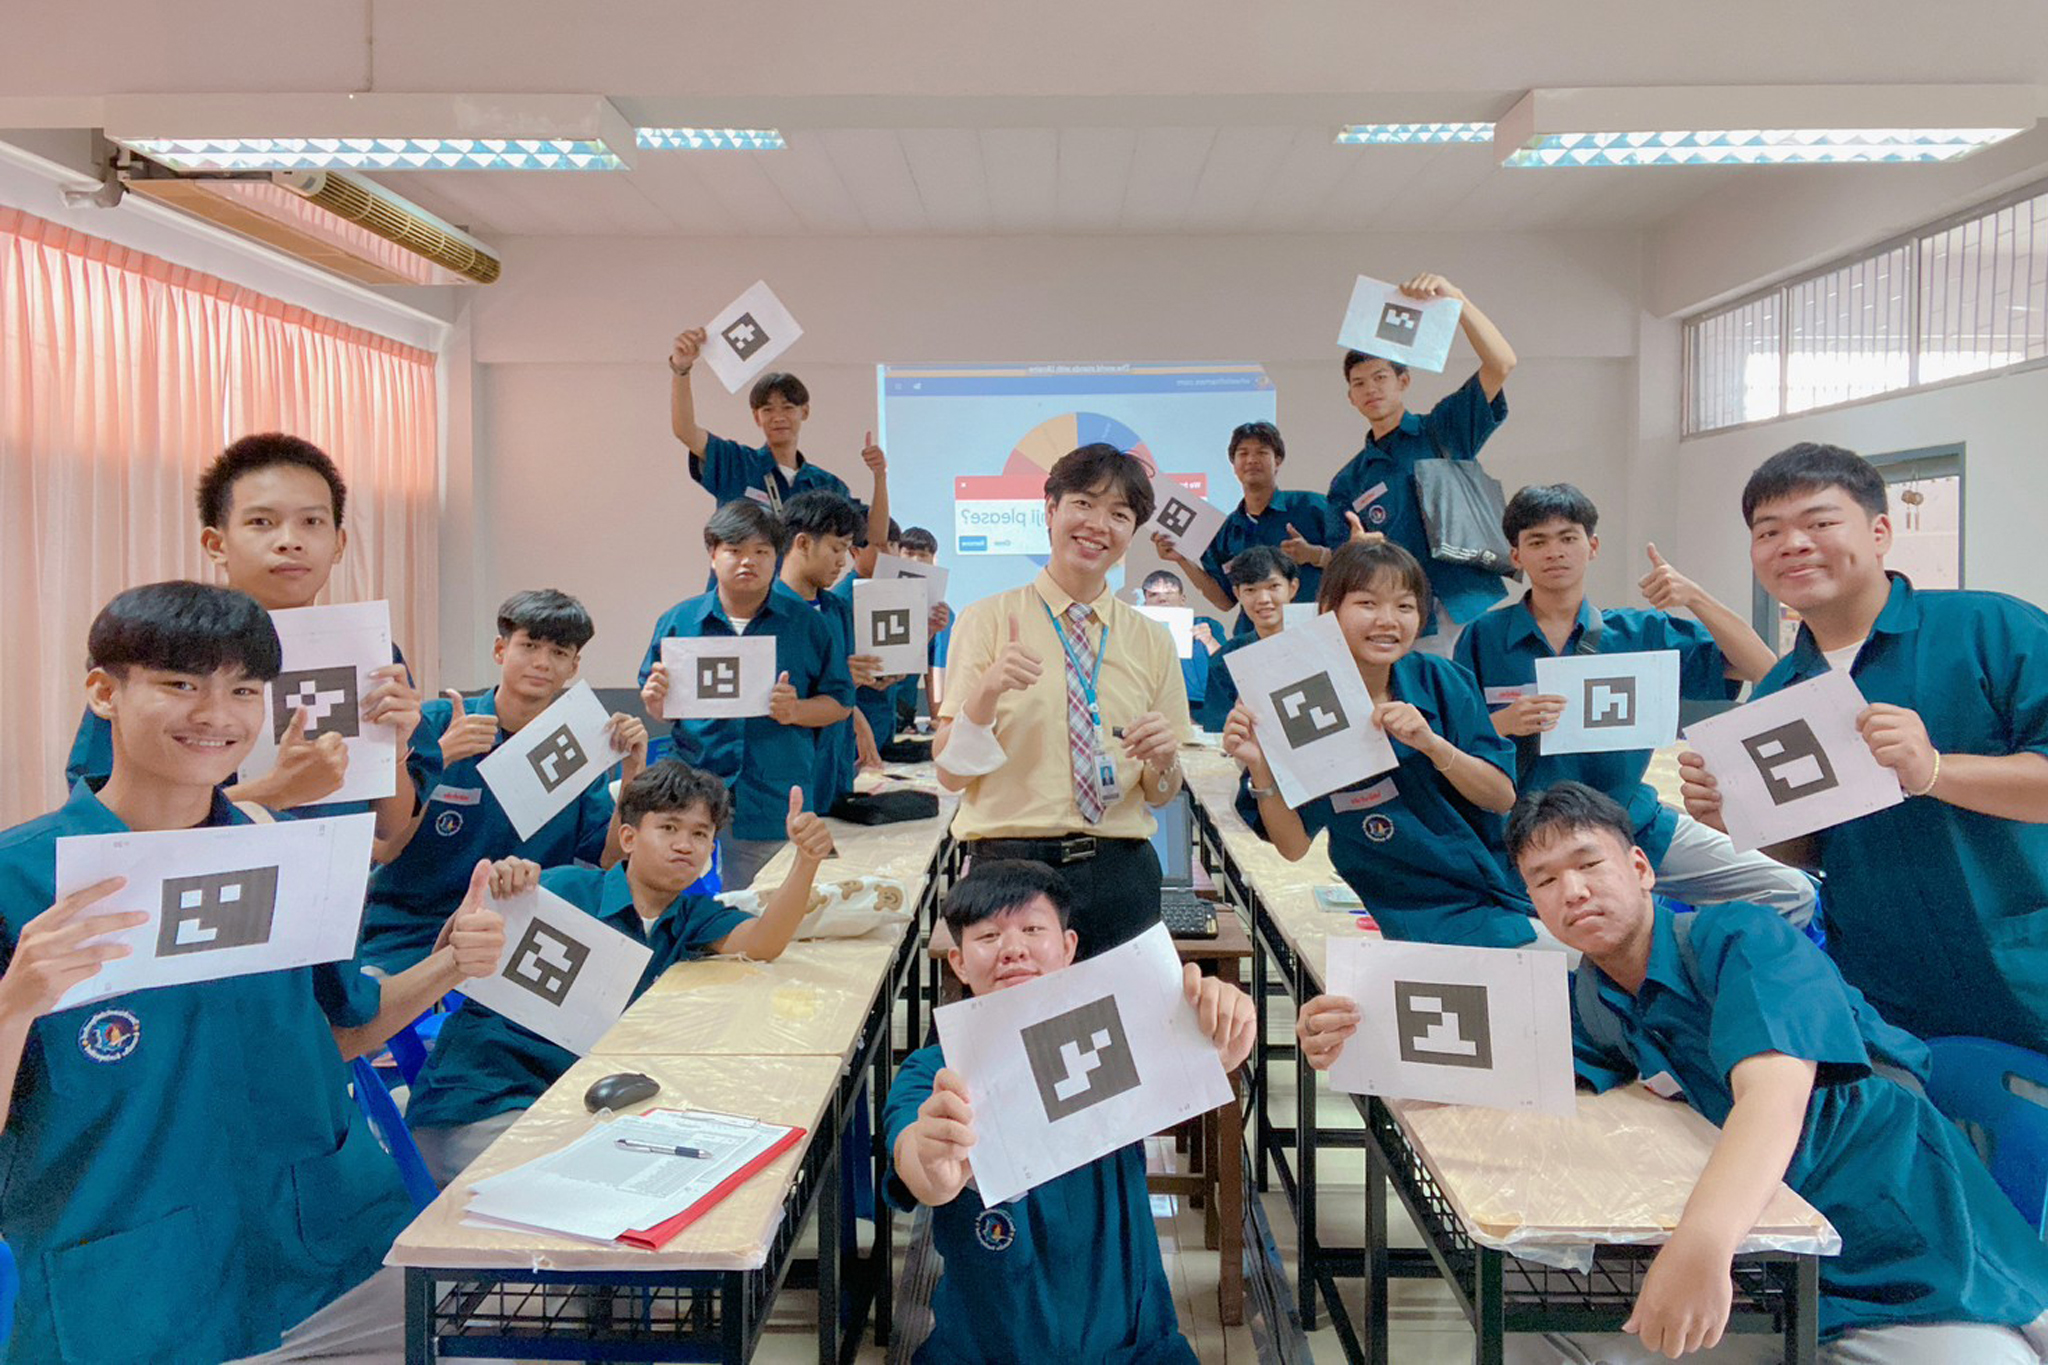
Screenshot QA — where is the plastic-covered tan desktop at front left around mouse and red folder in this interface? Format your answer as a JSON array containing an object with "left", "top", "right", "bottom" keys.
[{"left": 385, "top": 1056, "right": 840, "bottom": 1273}]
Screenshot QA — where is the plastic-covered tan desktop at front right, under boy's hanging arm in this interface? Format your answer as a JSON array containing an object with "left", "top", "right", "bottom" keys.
[{"left": 1389, "top": 1085, "right": 1841, "bottom": 1273}]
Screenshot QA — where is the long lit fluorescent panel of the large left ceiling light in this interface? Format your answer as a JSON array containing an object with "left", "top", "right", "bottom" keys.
[{"left": 125, "top": 137, "right": 625, "bottom": 172}]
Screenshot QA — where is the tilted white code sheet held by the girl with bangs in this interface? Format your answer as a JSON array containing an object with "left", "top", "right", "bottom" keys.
[{"left": 1223, "top": 612, "right": 1395, "bottom": 808}]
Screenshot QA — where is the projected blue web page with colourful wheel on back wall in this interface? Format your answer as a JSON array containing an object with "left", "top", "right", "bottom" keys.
[{"left": 879, "top": 364, "right": 1274, "bottom": 608}]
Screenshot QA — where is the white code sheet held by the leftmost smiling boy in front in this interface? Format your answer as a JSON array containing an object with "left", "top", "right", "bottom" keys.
[{"left": 52, "top": 814, "right": 377, "bottom": 1009}]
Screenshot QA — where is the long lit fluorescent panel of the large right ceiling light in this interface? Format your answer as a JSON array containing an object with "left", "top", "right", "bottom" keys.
[{"left": 1501, "top": 127, "right": 2023, "bottom": 168}]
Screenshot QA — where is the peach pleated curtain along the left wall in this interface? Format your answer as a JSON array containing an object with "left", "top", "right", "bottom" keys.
[{"left": 0, "top": 207, "right": 438, "bottom": 825}]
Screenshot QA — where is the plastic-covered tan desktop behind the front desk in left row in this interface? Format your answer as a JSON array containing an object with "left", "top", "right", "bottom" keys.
[{"left": 592, "top": 929, "right": 901, "bottom": 1058}]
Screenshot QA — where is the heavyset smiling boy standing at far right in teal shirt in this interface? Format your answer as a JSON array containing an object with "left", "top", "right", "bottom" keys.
[{"left": 1679, "top": 444, "right": 2048, "bottom": 1052}]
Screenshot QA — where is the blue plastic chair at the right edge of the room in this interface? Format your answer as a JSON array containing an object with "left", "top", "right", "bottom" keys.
[{"left": 1927, "top": 1038, "right": 2048, "bottom": 1238}]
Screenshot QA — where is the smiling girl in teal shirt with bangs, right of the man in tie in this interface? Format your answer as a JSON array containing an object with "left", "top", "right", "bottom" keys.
[{"left": 1223, "top": 540, "right": 1538, "bottom": 948}]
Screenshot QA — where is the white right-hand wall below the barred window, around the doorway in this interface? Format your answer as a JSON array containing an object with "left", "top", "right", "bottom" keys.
[{"left": 1675, "top": 368, "right": 2048, "bottom": 618}]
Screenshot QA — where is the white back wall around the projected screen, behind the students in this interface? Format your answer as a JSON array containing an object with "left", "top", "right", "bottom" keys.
[{"left": 460, "top": 233, "right": 1640, "bottom": 684}]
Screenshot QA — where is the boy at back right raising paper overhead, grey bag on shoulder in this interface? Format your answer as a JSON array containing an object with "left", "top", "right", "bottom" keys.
[{"left": 1329, "top": 274, "right": 1516, "bottom": 655}]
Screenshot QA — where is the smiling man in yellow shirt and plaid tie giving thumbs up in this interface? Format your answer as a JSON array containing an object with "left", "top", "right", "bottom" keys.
[{"left": 932, "top": 442, "right": 1188, "bottom": 958}]
